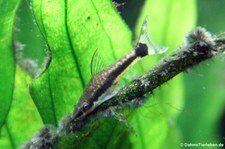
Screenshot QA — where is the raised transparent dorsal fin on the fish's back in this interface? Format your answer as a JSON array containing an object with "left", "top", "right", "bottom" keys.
[{"left": 91, "top": 49, "right": 106, "bottom": 76}]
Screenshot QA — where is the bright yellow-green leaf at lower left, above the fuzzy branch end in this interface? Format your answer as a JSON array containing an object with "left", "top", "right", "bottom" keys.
[{"left": 0, "top": 67, "right": 43, "bottom": 148}]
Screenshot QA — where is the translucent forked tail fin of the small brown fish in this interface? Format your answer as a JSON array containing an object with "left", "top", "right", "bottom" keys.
[{"left": 138, "top": 17, "right": 168, "bottom": 54}]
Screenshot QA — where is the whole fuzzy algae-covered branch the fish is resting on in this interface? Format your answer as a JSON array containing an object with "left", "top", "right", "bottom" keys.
[{"left": 18, "top": 27, "right": 225, "bottom": 149}]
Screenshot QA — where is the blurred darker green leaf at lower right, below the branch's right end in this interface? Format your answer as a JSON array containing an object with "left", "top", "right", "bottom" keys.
[{"left": 179, "top": 57, "right": 225, "bottom": 147}]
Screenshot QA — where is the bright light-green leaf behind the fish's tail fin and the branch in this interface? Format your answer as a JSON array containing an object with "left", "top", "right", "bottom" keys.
[{"left": 130, "top": 0, "right": 196, "bottom": 148}]
